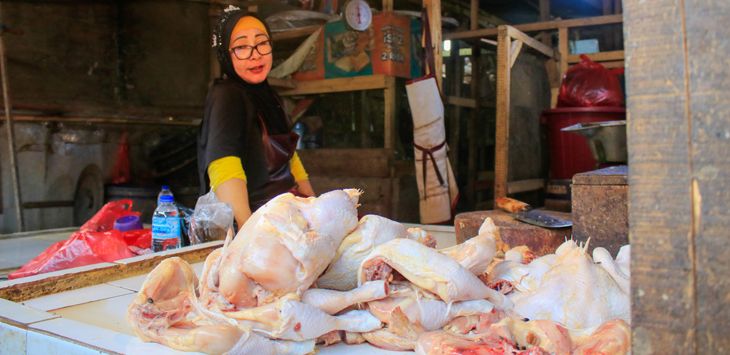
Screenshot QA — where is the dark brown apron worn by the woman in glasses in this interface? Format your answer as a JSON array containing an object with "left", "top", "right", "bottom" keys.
[{"left": 249, "top": 115, "right": 299, "bottom": 212}]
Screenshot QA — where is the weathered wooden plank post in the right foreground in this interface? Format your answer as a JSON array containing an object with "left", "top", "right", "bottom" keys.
[{"left": 623, "top": 0, "right": 730, "bottom": 354}]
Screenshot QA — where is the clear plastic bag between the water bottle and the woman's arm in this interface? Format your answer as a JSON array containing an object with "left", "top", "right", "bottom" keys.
[{"left": 190, "top": 191, "right": 233, "bottom": 244}]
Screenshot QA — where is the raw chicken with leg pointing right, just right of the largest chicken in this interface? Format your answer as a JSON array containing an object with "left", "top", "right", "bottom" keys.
[{"left": 358, "top": 239, "right": 510, "bottom": 308}]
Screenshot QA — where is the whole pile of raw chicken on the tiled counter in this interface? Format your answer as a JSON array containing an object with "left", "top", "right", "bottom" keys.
[{"left": 127, "top": 190, "right": 630, "bottom": 355}]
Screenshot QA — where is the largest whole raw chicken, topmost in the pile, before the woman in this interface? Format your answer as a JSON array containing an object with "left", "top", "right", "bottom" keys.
[{"left": 201, "top": 189, "right": 361, "bottom": 309}]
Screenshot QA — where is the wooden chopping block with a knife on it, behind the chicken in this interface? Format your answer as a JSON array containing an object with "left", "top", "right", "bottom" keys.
[{"left": 454, "top": 210, "right": 571, "bottom": 256}]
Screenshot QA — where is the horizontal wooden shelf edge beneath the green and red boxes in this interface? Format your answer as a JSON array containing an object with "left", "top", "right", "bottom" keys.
[{"left": 279, "top": 75, "right": 388, "bottom": 96}]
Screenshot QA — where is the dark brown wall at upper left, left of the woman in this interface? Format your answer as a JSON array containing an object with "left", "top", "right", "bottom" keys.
[{"left": 2, "top": 0, "right": 210, "bottom": 113}]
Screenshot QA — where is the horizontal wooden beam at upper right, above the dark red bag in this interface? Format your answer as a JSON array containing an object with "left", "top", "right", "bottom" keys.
[{"left": 443, "top": 14, "right": 623, "bottom": 40}]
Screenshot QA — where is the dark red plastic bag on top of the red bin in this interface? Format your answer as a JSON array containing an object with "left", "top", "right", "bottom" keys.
[{"left": 557, "top": 54, "right": 624, "bottom": 107}]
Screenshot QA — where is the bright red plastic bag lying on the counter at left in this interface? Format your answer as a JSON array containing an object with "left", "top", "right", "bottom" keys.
[{"left": 8, "top": 200, "right": 152, "bottom": 279}]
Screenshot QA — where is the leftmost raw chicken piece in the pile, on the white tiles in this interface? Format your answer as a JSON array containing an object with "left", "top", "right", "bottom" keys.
[{"left": 127, "top": 257, "right": 314, "bottom": 354}]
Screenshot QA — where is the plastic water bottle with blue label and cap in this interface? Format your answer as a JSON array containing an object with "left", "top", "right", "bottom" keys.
[{"left": 152, "top": 189, "right": 182, "bottom": 252}]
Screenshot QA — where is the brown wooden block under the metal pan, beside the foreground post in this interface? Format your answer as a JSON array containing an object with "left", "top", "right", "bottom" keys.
[{"left": 571, "top": 165, "right": 629, "bottom": 256}]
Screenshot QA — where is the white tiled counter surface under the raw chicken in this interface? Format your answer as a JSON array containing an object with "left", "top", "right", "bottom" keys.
[{"left": 0, "top": 225, "right": 455, "bottom": 355}]
